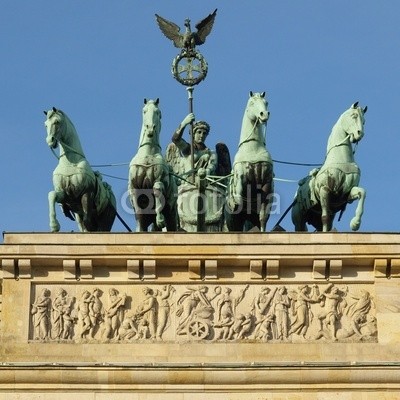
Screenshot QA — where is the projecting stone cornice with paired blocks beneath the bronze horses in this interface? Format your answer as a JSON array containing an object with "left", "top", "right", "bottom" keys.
[{"left": 0, "top": 232, "right": 400, "bottom": 279}]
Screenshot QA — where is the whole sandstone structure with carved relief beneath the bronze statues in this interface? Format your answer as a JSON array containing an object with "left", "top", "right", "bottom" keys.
[{"left": 0, "top": 232, "right": 400, "bottom": 400}]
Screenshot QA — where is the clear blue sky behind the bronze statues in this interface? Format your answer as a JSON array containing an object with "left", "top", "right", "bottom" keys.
[{"left": 0, "top": 0, "right": 400, "bottom": 232}]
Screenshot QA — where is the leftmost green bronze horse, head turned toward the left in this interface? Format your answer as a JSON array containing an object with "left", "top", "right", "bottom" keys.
[{"left": 44, "top": 107, "right": 117, "bottom": 232}]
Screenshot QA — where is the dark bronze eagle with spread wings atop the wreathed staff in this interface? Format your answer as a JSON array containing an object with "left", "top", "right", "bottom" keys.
[{"left": 156, "top": 9, "right": 217, "bottom": 51}]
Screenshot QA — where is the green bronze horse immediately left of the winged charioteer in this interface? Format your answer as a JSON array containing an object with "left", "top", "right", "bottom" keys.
[{"left": 128, "top": 99, "right": 177, "bottom": 232}]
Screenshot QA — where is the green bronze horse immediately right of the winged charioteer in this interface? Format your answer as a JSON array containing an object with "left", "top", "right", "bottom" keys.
[{"left": 225, "top": 92, "right": 274, "bottom": 232}]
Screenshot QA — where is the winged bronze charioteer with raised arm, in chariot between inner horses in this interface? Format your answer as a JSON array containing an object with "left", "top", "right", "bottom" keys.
[{"left": 166, "top": 113, "right": 231, "bottom": 232}]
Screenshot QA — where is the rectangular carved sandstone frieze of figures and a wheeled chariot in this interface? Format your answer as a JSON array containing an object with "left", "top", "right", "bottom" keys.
[{"left": 28, "top": 283, "right": 377, "bottom": 343}]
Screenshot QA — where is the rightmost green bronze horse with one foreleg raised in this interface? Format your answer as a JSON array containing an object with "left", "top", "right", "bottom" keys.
[{"left": 292, "top": 102, "right": 367, "bottom": 232}]
